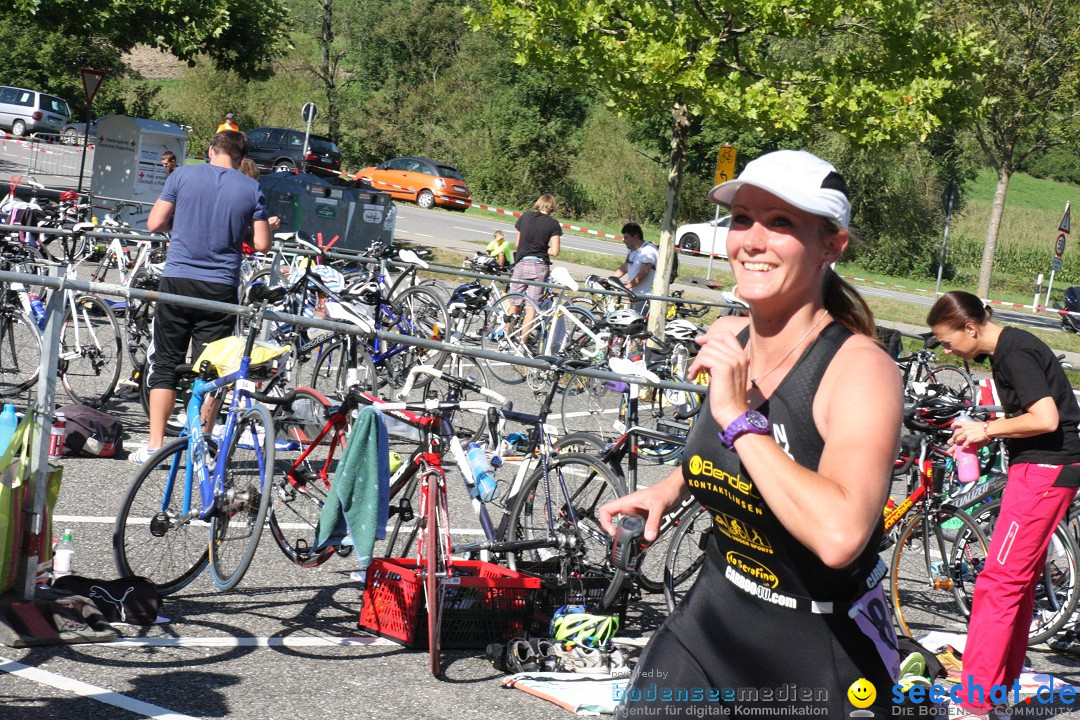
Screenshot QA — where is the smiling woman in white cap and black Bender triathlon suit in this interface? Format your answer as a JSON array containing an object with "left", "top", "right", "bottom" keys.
[{"left": 599, "top": 151, "right": 902, "bottom": 718}]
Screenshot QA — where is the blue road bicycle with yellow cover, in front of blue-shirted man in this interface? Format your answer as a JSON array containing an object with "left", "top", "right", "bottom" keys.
[{"left": 112, "top": 289, "right": 284, "bottom": 595}]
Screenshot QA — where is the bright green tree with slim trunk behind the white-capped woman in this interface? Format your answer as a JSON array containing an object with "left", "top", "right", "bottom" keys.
[{"left": 470, "top": 0, "right": 982, "bottom": 332}]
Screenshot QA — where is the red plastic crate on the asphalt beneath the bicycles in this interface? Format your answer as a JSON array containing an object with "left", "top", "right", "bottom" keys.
[{"left": 359, "top": 558, "right": 540, "bottom": 649}]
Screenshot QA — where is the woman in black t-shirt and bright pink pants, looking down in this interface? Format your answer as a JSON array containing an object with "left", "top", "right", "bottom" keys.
[{"left": 927, "top": 290, "right": 1080, "bottom": 719}]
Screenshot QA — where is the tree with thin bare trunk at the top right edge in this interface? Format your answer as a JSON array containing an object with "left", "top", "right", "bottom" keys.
[{"left": 948, "top": 0, "right": 1080, "bottom": 297}]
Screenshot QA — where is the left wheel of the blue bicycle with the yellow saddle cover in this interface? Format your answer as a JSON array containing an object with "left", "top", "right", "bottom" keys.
[{"left": 112, "top": 438, "right": 210, "bottom": 595}]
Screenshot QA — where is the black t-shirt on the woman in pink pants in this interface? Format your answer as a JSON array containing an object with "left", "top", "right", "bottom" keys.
[{"left": 990, "top": 327, "right": 1080, "bottom": 465}]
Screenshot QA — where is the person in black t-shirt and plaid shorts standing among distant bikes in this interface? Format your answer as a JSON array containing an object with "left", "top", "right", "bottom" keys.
[{"left": 505, "top": 194, "right": 563, "bottom": 342}]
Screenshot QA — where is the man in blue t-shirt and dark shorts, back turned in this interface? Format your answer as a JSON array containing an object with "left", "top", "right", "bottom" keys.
[{"left": 130, "top": 131, "right": 270, "bottom": 464}]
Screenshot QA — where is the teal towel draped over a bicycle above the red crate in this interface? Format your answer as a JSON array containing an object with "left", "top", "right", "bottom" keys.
[{"left": 315, "top": 406, "right": 390, "bottom": 570}]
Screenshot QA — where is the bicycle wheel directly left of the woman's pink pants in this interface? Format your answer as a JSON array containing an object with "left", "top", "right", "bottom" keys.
[{"left": 890, "top": 507, "right": 987, "bottom": 637}]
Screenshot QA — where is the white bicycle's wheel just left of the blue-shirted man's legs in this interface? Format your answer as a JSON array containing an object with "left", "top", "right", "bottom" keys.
[{"left": 59, "top": 295, "right": 123, "bottom": 407}]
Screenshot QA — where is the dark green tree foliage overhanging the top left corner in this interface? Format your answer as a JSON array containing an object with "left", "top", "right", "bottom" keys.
[{"left": 8, "top": 0, "right": 288, "bottom": 78}]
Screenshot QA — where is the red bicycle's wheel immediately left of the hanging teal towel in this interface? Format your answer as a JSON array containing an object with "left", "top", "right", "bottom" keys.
[{"left": 270, "top": 388, "right": 347, "bottom": 568}]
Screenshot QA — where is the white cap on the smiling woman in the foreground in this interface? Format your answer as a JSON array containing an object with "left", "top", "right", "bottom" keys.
[{"left": 708, "top": 150, "right": 851, "bottom": 230}]
